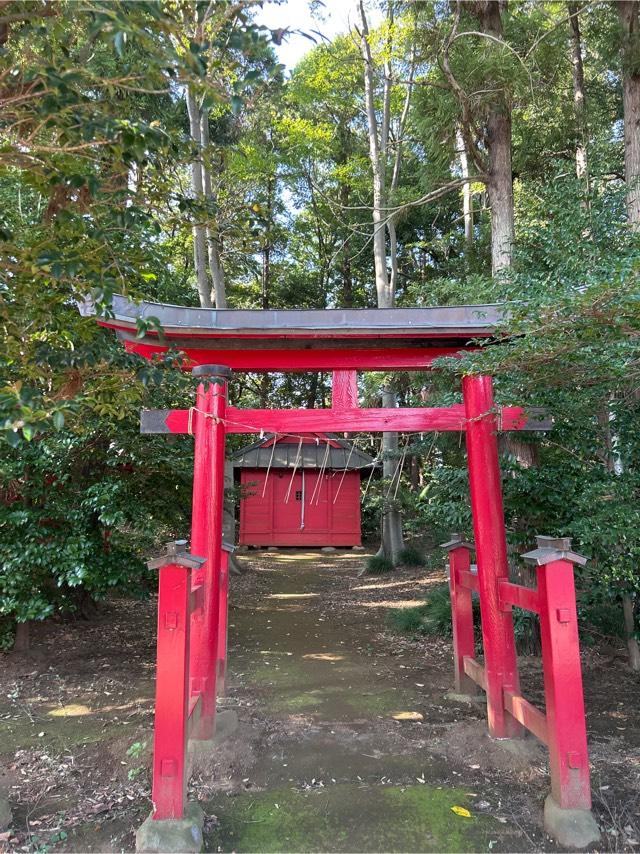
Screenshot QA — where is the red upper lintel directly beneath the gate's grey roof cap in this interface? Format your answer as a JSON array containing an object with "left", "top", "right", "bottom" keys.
[{"left": 124, "top": 341, "right": 464, "bottom": 372}]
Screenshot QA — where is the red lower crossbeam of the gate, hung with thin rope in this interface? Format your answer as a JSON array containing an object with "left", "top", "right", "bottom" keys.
[{"left": 166, "top": 404, "right": 526, "bottom": 434}]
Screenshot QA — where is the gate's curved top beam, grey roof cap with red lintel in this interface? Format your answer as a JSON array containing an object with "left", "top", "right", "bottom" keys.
[{"left": 94, "top": 296, "right": 505, "bottom": 372}]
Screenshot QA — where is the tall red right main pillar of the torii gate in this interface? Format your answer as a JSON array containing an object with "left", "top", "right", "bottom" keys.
[{"left": 462, "top": 376, "right": 523, "bottom": 738}]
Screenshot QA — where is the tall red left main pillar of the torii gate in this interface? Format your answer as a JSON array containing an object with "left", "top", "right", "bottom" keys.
[{"left": 190, "top": 365, "right": 231, "bottom": 740}]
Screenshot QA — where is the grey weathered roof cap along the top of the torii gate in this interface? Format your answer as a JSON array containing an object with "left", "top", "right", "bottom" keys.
[{"left": 92, "top": 296, "right": 506, "bottom": 349}]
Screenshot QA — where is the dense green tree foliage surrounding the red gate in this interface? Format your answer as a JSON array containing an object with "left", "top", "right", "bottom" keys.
[{"left": 0, "top": 0, "right": 640, "bottom": 664}]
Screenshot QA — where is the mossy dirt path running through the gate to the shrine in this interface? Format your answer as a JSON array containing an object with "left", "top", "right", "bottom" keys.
[{"left": 200, "top": 553, "right": 537, "bottom": 851}]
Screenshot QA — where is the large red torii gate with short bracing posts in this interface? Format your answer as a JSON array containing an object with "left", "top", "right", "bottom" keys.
[{"left": 98, "top": 297, "right": 599, "bottom": 851}]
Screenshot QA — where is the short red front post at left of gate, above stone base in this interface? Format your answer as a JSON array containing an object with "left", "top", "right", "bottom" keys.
[{"left": 152, "top": 564, "right": 191, "bottom": 820}]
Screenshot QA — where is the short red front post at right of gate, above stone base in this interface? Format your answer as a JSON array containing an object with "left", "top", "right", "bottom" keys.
[{"left": 537, "top": 560, "right": 591, "bottom": 810}]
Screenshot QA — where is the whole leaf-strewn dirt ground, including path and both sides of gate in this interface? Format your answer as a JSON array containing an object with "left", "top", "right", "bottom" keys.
[{"left": 0, "top": 551, "right": 640, "bottom": 852}]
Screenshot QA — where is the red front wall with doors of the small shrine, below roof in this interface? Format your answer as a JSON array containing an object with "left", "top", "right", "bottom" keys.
[{"left": 239, "top": 469, "right": 361, "bottom": 546}]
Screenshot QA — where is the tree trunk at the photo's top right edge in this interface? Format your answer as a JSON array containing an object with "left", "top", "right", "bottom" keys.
[{"left": 616, "top": 0, "right": 640, "bottom": 231}]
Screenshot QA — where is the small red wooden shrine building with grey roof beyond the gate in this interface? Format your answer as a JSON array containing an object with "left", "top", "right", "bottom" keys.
[{"left": 233, "top": 433, "right": 374, "bottom": 547}]
